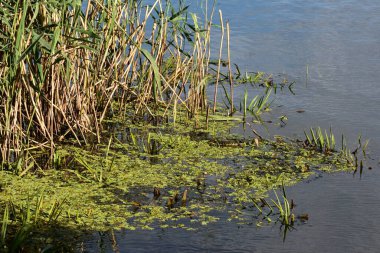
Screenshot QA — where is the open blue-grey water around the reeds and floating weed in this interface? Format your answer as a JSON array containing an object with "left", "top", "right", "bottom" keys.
[{"left": 81, "top": 0, "right": 380, "bottom": 253}]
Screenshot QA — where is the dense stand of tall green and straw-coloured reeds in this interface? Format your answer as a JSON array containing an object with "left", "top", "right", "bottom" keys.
[{"left": 0, "top": 0, "right": 221, "bottom": 166}]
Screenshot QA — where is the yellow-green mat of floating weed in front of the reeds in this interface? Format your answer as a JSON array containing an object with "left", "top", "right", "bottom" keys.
[{"left": 0, "top": 110, "right": 352, "bottom": 235}]
